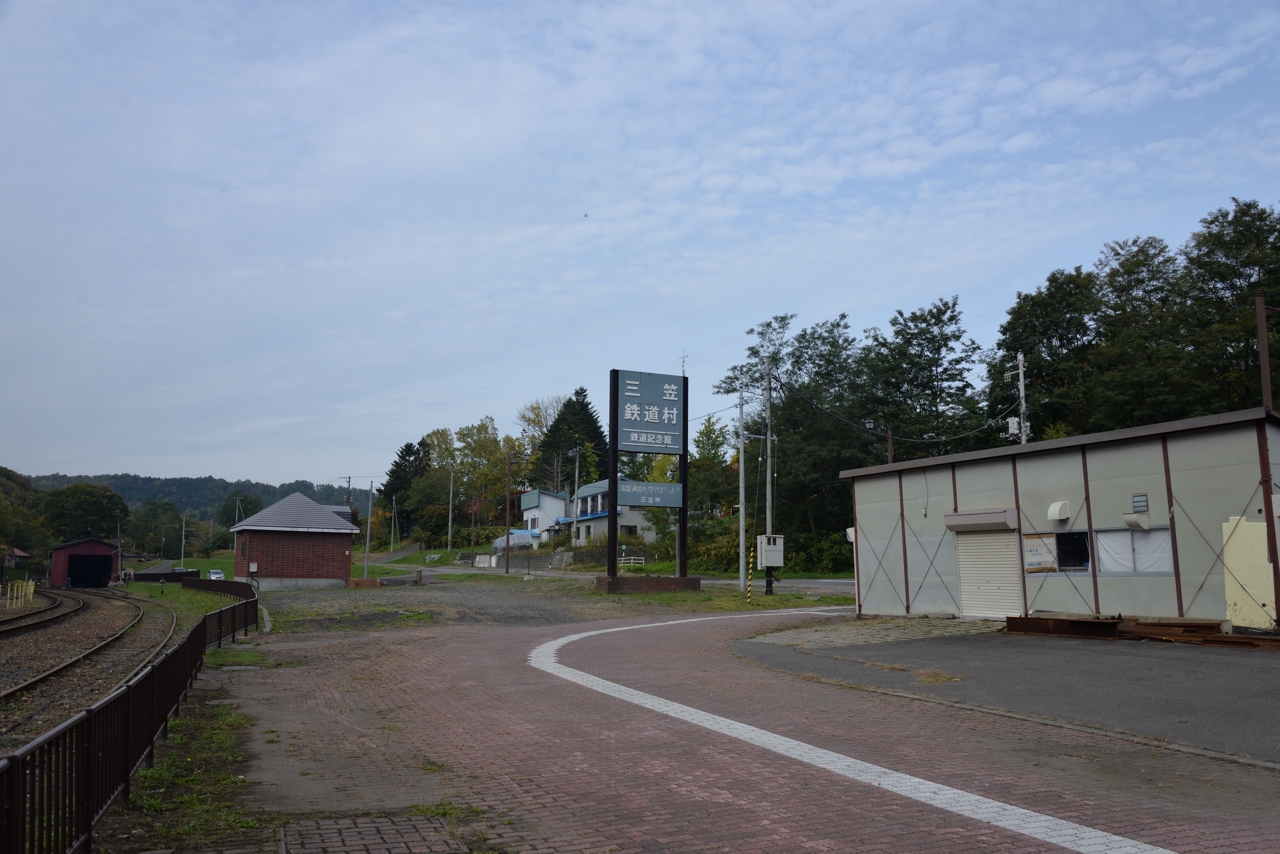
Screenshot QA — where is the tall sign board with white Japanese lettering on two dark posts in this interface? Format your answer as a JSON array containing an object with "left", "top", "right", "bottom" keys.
[{"left": 608, "top": 370, "right": 689, "bottom": 577}]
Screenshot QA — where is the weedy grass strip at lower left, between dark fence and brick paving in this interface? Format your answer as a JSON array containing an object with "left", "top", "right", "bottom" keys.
[{"left": 93, "top": 691, "right": 283, "bottom": 854}]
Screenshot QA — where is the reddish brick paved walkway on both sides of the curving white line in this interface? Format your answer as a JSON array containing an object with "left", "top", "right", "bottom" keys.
[{"left": 217, "top": 613, "right": 1280, "bottom": 854}]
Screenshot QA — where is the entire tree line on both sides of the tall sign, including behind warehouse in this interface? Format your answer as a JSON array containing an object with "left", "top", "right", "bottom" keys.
[{"left": 375, "top": 198, "right": 1280, "bottom": 572}]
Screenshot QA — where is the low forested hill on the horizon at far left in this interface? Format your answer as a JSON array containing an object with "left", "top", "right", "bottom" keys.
[{"left": 31, "top": 474, "right": 369, "bottom": 519}]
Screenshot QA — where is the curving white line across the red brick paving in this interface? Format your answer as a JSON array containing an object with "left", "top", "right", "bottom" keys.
[{"left": 529, "top": 609, "right": 1172, "bottom": 854}]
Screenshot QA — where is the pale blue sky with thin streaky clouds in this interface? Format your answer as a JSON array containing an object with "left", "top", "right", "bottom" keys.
[{"left": 0, "top": 0, "right": 1280, "bottom": 483}]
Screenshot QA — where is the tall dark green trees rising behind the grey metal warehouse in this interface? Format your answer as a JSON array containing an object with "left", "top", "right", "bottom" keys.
[{"left": 716, "top": 198, "right": 1280, "bottom": 571}]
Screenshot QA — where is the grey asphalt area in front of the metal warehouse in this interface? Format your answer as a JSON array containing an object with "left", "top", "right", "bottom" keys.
[{"left": 733, "top": 634, "right": 1280, "bottom": 762}]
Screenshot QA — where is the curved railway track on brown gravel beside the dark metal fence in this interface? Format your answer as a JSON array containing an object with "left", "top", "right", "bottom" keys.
[{"left": 0, "top": 590, "right": 178, "bottom": 753}]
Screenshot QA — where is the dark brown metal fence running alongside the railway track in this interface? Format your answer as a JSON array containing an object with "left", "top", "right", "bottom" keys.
[{"left": 0, "top": 579, "right": 257, "bottom": 854}]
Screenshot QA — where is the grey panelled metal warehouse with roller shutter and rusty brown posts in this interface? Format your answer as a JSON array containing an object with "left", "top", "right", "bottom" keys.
[{"left": 841, "top": 408, "right": 1280, "bottom": 630}]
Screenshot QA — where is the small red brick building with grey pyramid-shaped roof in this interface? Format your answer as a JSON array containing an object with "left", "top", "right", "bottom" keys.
[{"left": 232, "top": 492, "right": 360, "bottom": 590}]
